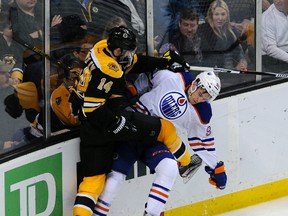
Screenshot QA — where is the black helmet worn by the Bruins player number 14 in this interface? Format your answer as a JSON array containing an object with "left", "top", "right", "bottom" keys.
[{"left": 107, "top": 26, "right": 136, "bottom": 51}]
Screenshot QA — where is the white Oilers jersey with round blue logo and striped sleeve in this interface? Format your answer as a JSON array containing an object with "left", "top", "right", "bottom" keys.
[{"left": 136, "top": 70, "right": 217, "bottom": 168}]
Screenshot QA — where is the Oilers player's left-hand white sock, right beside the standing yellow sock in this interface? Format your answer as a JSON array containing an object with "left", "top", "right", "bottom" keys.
[{"left": 94, "top": 170, "right": 126, "bottom": 216}]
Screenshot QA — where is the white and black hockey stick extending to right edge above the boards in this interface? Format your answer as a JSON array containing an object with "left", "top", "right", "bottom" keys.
[{"left": 189, "top": 66, "right": 288, "bottom": 78}]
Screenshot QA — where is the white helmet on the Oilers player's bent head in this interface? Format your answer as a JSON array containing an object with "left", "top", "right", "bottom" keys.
[{"left": 195, "top": 71, "right": 221, "bottom": 102}]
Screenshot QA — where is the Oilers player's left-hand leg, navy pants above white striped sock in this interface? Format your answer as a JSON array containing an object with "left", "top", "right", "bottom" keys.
[{"left": 94, "top": 143, "right": 138, "bottom": 216}]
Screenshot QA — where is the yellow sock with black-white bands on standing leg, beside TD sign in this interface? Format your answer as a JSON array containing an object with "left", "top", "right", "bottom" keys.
[{"left": 73, "top": 174, "right": 106, "bottom": 216}]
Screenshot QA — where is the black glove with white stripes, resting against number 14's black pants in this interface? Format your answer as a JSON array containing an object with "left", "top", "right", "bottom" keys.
[{"left": 108, "top": 116, "right": 137, "bottom": 135}]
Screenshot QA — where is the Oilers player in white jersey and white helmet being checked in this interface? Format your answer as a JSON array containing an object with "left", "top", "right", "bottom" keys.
[{"left": 94, "top": 70, "right": 227, "bottom": 216}]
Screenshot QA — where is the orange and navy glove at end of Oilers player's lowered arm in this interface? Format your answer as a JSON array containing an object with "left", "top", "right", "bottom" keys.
[{"left": 205, "top": 161, "right": 227, "bottom": 190}]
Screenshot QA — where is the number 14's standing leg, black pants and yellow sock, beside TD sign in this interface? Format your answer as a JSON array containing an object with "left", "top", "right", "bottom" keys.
[{"left": 73, "top": 122, "right": 114, "bottom": 216}]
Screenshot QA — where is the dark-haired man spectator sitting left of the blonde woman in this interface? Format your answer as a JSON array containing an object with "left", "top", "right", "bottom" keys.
[{"left": 169, "top": 9, "right": 202, "bottom": 65}]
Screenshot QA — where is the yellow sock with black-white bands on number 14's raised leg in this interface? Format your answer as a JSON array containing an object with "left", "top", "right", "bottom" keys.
[{"left": 157, "top": 119, "right": 190, "bottom": 166}]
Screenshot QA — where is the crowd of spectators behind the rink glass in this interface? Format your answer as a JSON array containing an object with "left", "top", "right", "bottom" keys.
[{"left": 0, "top": 0, "right": 288, "bottom": 153}]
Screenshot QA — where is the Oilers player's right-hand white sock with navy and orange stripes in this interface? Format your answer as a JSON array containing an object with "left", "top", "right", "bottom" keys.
[{"left": 145, "top": 158, "right": 179, "bottom": 215}]
